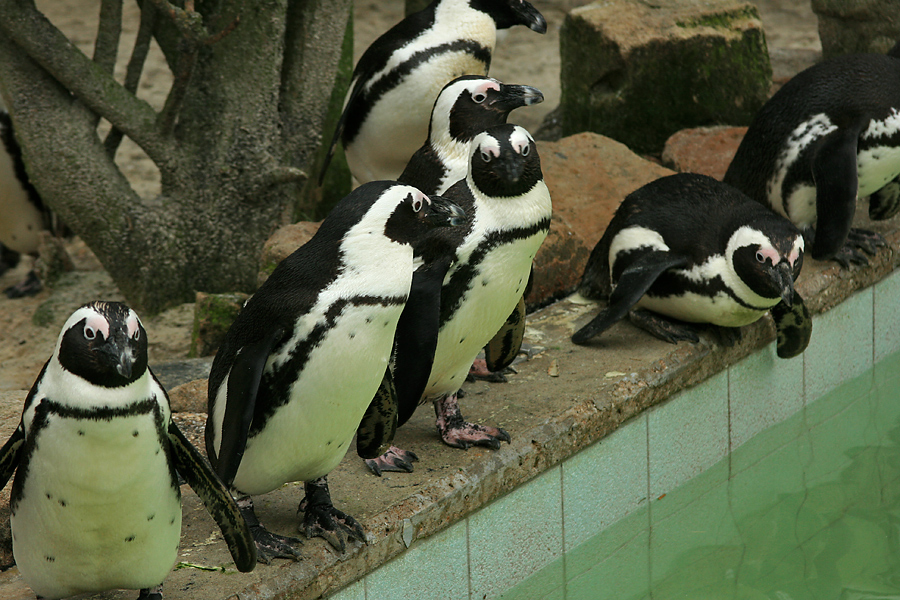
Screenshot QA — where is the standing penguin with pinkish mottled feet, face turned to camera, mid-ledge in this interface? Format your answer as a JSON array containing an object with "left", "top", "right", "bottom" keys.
[{"left": 367, "top": 124, "right": 552, "bottom": 474}]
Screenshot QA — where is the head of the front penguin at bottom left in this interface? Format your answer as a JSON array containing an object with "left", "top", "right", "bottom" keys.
[{"left": 55, "top": 300, "right": 147, "bottom": 388}]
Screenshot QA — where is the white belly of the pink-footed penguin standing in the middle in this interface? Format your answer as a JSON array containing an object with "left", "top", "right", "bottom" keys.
[{"left": 424, "top": 232, "right": 546, "bottom": 398}]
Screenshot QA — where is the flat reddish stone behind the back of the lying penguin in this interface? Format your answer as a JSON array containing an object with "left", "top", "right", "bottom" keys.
[{"left": 662, "top": 125, "right": 747, "bottom": 181}]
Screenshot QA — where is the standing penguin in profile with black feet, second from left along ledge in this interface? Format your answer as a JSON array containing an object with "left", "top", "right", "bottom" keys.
[{"left": 206, "top": 181, "right": 464, "bottom": 561}]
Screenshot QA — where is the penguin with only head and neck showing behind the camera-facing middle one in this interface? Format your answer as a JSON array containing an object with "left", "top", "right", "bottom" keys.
[{"left": 397, "top": 75, "right": 544, "bottom": 194}]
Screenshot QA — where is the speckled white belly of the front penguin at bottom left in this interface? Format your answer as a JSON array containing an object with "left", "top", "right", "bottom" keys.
[{"left": 11, "top": 414, "right": 181, "bottom": 598}]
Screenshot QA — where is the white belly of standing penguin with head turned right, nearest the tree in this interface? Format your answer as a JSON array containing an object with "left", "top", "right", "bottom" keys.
[{"left": 234, "top": 306, "right": 402, "bottom": 494}]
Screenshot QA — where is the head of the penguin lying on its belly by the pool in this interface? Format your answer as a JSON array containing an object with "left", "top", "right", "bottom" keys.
[{"left": 727, "top": 223, "right": 803, "bottom": 306}]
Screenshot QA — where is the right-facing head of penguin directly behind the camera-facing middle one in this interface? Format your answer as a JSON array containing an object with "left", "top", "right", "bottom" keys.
[{"left": 428, "top": 75, "right": 544, "bottom": 143}]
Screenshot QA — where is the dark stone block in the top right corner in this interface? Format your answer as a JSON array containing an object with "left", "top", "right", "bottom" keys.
[{"left": 812, "top": 0, "right": 900, "bottom": 58}]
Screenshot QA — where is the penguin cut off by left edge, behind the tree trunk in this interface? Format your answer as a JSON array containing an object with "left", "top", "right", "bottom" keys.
[{"left": 0, "top": 107, "right": 61, "bottom": 298}]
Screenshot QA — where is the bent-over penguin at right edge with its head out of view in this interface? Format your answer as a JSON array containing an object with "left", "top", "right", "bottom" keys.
[{"left": 723, "top": 44, "right": 900, "bottom": 266}]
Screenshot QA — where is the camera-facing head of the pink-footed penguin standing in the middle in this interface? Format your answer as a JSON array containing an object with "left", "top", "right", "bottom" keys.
[{"left": 468, "top": 124, "right": 544, "bottom": 197}]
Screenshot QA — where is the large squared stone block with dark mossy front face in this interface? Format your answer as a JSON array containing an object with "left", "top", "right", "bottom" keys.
[{"left": 560, "top": 0, "right": 772, "bottom": 153}]
